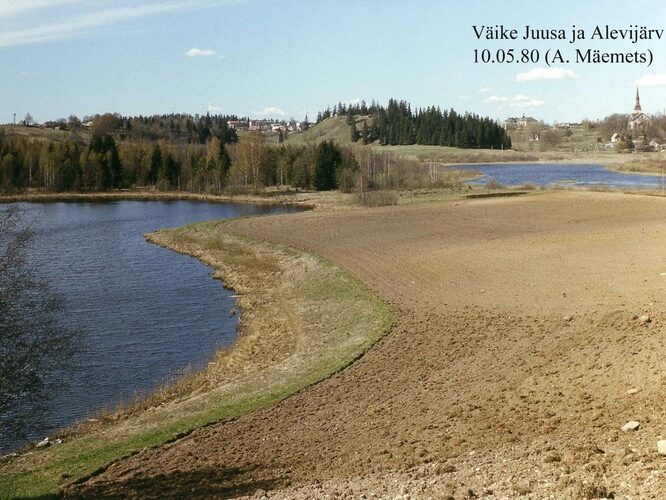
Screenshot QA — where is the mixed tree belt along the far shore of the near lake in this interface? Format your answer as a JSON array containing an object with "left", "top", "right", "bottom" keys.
[{"left": 0, "top": 125, "right": 354, "bottom": 193}]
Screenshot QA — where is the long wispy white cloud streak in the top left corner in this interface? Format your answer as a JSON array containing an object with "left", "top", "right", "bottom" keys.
[{"left": 0, "top": 0, "right": 243, "bottom": 47}]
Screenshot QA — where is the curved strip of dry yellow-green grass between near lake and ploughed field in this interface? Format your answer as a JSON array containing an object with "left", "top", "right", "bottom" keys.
[{"left": 0, "top": 222, "right": 391, "bottom": 498}]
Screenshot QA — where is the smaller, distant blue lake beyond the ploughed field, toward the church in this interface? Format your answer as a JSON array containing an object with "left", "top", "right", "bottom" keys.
[{"left": 454, "top": 163, "right": 662, "bottom": 189}]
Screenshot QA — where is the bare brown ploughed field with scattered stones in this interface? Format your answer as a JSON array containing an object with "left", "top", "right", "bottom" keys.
[{"left": 66, "top": 191, "right": 666, "bottom": 498}]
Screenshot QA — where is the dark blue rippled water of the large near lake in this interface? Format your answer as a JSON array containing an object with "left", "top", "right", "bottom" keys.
[{"left": 0, "top": 201, "right": 298, "bottom": 452}]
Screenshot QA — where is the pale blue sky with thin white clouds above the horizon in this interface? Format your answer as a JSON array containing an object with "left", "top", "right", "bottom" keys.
[{"left": 0, "top": 0, "right": 666, "bottom": 123}]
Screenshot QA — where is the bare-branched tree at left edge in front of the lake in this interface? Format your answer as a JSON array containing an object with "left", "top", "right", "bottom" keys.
[{"left": 0, "top": 205, "right": 81, "bottom": 442}]
